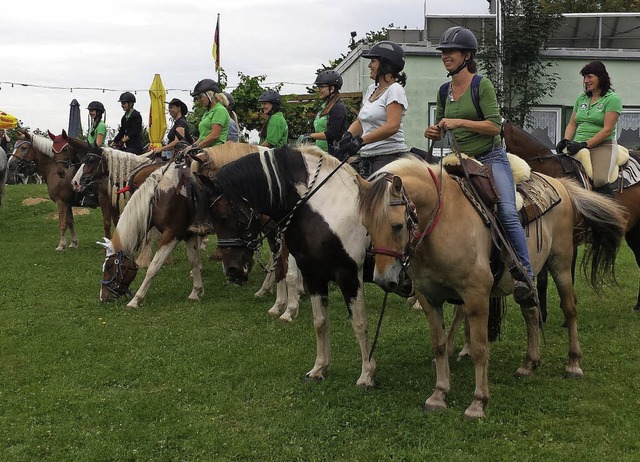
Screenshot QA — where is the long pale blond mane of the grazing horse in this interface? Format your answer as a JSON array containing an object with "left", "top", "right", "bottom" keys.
[{"left": 114, "top": 168, "right": 164, "bottom": 255}]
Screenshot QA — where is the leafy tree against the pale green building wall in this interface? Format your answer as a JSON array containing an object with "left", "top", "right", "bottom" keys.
[{"left": 478, "top": 0, "right": 563, "bottom": 126}]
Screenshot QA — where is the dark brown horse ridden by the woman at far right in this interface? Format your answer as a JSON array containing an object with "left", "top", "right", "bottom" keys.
[{"left": 504, "top": 122, "right": 640, "bottom": 311}]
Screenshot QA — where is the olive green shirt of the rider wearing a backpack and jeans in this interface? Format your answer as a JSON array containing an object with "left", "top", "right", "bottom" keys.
[{"left": 436, "top": 77, "right": 502, "bottom": 157}]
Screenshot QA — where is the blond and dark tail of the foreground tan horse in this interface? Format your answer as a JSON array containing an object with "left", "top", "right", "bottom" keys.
[{"left": 559, "top": 178, "right": 627, "bottom": 289}]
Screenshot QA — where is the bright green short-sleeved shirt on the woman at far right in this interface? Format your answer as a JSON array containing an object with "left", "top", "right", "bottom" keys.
[{"left": 573, "top": 90, "right": 622, "bottom": 143}]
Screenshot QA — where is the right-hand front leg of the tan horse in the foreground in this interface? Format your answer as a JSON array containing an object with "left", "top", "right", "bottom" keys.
[{"left": 464, "top": 293, "right": 489, "bottom": 419}]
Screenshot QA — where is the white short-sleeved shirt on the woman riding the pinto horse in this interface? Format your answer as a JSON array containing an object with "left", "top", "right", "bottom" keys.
[{"left": 358, "top": 82, "right": 409, "bottom": 157}]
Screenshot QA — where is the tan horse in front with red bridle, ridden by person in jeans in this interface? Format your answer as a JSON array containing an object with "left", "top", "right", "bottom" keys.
[{"left": 359, "top": 157, "right": 625, "bottom": 418}]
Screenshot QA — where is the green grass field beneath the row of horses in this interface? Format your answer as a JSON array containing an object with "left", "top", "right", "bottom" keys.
[{"left": 0, "top": 185, "right": 640, "bottom": 461}]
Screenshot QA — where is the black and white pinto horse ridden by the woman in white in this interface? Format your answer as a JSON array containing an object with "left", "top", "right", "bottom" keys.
[{"left": 205, "top": 146, "right": 376, "bottom": 386}]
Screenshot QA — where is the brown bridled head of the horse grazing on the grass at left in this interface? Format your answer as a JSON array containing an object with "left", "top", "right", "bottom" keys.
[{"left": 96, "top": 237, "right": 138, "bottom": 302}]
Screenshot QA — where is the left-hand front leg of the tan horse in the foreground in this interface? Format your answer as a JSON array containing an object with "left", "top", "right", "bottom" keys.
[{"left": 416, "top": 290, "right": 451, "bottom": 412}]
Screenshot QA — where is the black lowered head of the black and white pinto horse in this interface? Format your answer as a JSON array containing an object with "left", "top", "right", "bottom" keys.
[{"left": 200, "top": 175, "right": 262, "bottom": 285}]
